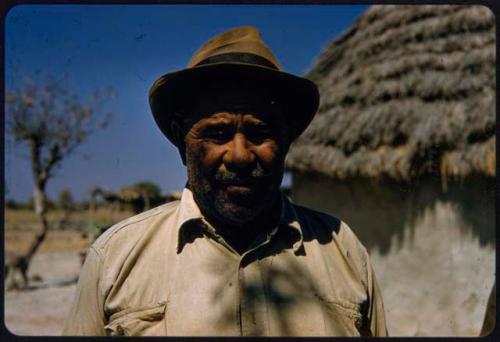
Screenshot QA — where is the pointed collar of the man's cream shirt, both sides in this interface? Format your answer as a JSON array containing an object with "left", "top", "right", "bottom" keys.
[{"left": 176, "top": 188, "right": 304, "bottom": 253}]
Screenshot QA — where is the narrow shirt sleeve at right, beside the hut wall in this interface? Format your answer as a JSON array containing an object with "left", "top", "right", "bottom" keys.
[{"left": 367, "top": 257, "right": 388, "bottom": 337}]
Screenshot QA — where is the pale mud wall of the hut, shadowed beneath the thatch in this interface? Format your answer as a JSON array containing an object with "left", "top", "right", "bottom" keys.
[{"left": 291, "top": 174, "right": 495, "bottom": 336}]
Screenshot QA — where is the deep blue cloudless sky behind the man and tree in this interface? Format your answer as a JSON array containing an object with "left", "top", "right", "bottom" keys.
[{"left": 4, "top": 4, "right": 367, "bottom": 200}]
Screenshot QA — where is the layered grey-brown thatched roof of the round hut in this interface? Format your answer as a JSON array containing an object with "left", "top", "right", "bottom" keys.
[{"left": 287, "top": 5, "right": 496, "bottom": 180}]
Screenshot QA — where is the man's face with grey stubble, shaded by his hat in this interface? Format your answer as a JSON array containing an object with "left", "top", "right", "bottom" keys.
[{"left": 185, "top": 83, "right": 289, "bottom": 224}]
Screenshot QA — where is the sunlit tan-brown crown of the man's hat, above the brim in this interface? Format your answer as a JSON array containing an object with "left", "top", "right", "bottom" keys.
[{"left": 188, "top": 26, "right": 282, "bottom": 71}]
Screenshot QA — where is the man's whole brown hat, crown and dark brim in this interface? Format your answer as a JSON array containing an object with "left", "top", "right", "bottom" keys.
[{"left": 149, "top": 26, "right": 319, "bottom": 145}]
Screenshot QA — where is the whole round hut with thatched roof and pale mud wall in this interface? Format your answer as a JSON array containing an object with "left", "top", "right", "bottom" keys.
[{"left": 286, "top": 5, "right": 496, "bottom": 335}]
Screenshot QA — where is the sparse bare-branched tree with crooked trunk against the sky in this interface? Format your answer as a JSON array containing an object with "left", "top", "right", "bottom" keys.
[{"left": 6, "top": 76, "right": 112, "bottom": 286}]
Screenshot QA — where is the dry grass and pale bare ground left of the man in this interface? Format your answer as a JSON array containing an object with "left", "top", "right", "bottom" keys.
[{"left": 4, "top": 208, "right": 137, "bottom": 336}]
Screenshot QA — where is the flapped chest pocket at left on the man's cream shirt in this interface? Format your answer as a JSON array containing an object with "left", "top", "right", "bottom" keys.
[{"left": 104, "top": 302, "right": 167, "bottom": 336}]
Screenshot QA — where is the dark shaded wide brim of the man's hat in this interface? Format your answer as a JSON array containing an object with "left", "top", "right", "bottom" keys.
[{"left": 149, "top": 63, "right": 319, "bottom": 145}]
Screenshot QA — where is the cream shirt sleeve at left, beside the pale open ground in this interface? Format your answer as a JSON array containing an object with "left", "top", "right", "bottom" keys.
[{"left": 62, "top": 247, "right": 105, "bottom": 336}]
